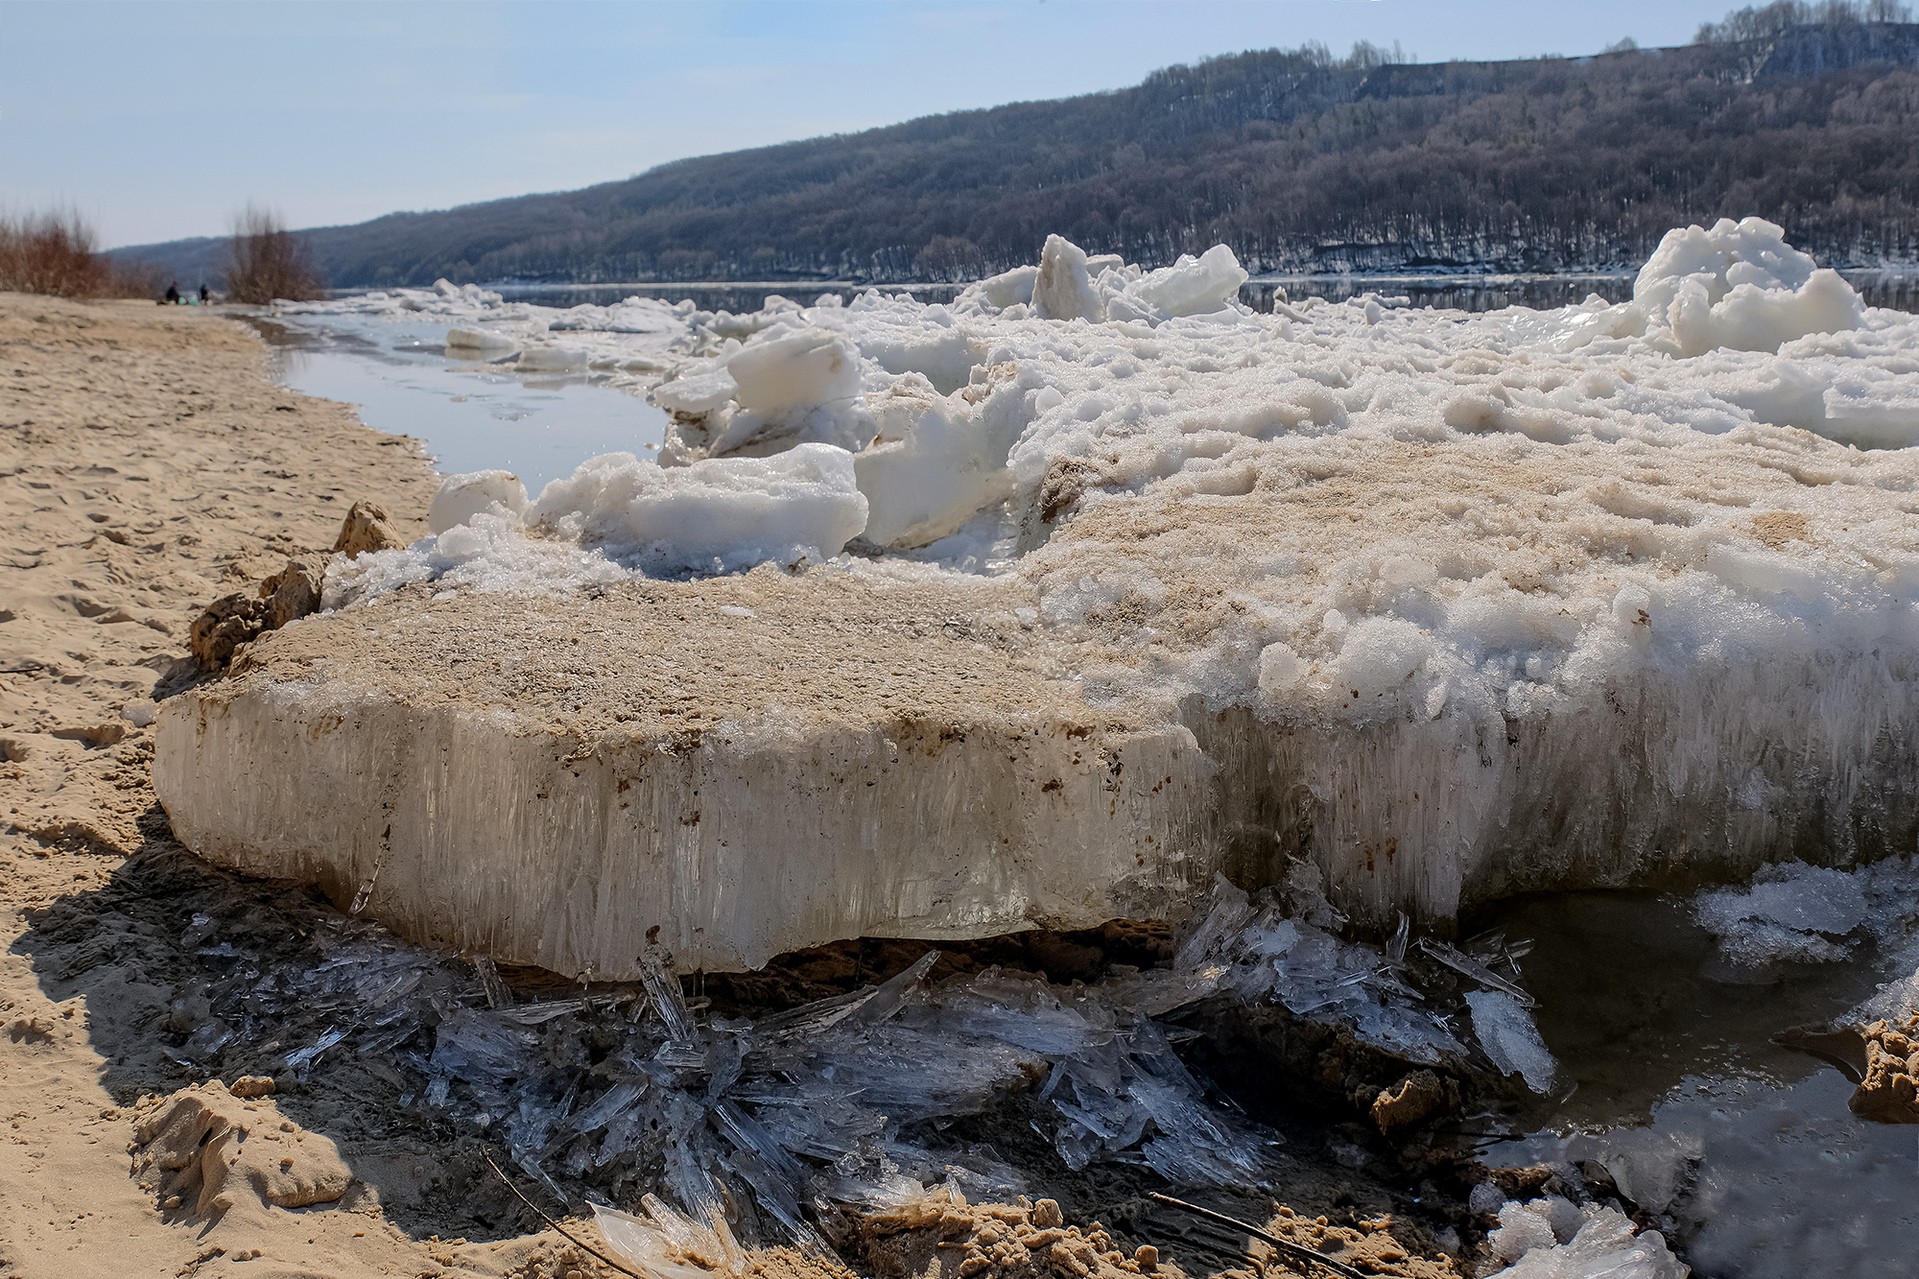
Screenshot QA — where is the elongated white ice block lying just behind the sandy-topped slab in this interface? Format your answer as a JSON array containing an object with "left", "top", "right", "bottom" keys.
[{"left": 528, "top": 444, "right": 865, "bottom": 572}]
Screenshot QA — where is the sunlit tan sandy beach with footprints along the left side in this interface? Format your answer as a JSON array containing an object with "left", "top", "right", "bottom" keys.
[{"left": 0, "top": 294, "right": 529, "bottom": 1277}]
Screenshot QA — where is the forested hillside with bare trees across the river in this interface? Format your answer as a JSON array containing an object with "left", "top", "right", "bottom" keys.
[{"left": 125, "top": 4, "right": 1919, "bottom": 286}]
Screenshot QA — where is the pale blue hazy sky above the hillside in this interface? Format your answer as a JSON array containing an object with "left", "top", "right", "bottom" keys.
[{"left": 0, "top": 0, "right": 1737, "bottom": 248}]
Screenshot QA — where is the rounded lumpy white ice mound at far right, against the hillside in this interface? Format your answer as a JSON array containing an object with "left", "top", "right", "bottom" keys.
[{"left": 1631, "top": 217, "right": 1865, "bottom": 355}]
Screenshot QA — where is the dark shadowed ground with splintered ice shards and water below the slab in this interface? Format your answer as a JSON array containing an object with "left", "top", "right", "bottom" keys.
[{"left": 21, "top": 802, "right": 1919, "bottom": 1275}]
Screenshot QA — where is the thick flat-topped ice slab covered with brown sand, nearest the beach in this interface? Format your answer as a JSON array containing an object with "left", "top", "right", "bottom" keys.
[{"left": 155, "top": 574, "right": 1209, "bottom": 977}]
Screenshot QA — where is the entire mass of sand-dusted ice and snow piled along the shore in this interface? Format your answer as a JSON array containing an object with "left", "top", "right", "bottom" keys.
[{"left": 159, "top": 219, "right": 1919, "bottom": 971}]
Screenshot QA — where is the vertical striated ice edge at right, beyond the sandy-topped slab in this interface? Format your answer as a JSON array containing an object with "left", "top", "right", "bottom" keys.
[{"left": 1190, "top": 653, "right": 1919, "bottom": 926}]
